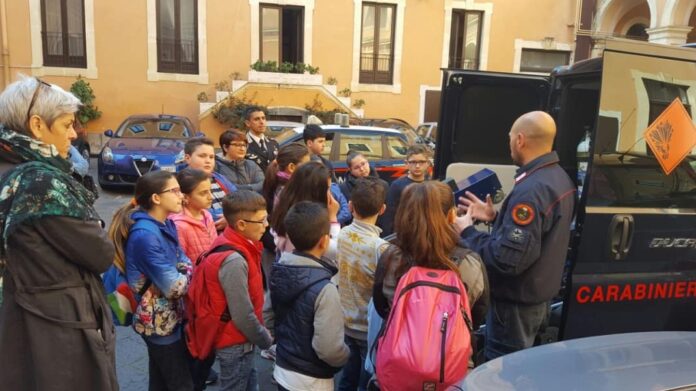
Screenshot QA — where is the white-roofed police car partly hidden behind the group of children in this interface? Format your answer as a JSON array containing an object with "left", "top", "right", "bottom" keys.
[{"left": 276, "top": 125, "right": 408, "bottom": 182}]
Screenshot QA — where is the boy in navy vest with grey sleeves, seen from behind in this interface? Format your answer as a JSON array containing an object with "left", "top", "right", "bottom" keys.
[{"left": 271, "top": 201, "right": 350, "bottom": 391}]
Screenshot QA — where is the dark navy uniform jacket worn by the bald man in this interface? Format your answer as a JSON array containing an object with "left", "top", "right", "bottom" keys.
[{"left": 461, "top": 152, "right": 576, "bottom": 304}]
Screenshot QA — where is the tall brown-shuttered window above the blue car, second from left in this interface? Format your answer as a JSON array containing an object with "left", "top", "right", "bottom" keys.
[{"left": 157, "top": 0, "right": 198, "bottom": 74}]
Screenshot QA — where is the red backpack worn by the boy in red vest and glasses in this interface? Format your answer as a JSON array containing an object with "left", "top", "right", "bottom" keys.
[{"left": 184, "top": 244, "right": 244, "bottom": 360}]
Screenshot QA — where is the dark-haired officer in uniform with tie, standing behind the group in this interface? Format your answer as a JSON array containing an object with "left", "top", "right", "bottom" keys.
[{"left": 244, "top": 106, "right": 278, "bottom": 173}]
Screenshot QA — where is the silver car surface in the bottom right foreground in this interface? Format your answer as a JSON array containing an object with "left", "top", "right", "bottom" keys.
[{"left": 452, "top": 331, "right": 696, "bottom": 391}]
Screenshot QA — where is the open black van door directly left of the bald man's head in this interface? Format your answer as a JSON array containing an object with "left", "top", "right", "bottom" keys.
[{"left": 435, "top": 69, "right": 550, "bottom": 198}]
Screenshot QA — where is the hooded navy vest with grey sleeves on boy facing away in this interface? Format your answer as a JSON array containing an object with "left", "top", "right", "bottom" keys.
[{"left": 271, "top": 252, "right": 349, "bottom": 382}]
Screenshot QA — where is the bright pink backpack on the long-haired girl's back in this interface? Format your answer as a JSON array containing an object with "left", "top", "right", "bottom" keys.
[{"left": 376, "top": 266, "right": 473, "bottom": 391}]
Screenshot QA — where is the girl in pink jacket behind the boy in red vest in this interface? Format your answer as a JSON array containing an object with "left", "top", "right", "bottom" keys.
[{"left": 169, "top": 168, "right": 217, "bottom": 266}]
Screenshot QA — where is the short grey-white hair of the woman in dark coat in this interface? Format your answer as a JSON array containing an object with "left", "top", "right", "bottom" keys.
[{"left": 0, "top": 74, "right": 81, "bottom": 135}]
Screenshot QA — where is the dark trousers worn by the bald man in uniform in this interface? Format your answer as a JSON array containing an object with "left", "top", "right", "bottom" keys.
[{"left": 484, "top": 299, "right": 549, "bottom": 360}]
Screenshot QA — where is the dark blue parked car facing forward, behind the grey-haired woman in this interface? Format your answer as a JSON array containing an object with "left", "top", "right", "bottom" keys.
[{"left": 97, "top": 114, "right": 202, "bottom": 187}]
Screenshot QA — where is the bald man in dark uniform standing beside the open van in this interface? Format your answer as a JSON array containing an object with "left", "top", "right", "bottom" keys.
[{"left": 456, "top": 111, "right": 576, "bottom": 360}]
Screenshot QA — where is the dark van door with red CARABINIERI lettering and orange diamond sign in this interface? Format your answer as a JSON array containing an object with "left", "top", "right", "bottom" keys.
[{"left": 560, "top": 41, "right": 696, "bottom": 339}]
